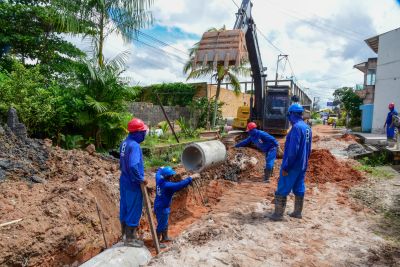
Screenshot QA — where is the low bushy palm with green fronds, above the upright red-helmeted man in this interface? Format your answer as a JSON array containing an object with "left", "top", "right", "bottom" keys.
[{"left": 78, "top": 53, "right": 137, "bottom": 148}]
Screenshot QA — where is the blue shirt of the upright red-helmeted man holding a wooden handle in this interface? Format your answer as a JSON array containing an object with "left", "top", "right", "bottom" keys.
[{"left": 119, "top": 132, "right": 144, "bottom": 191}]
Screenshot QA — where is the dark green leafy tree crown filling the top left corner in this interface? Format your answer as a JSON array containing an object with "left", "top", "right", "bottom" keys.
[{"left": 0, "top": 0, "right": 88, "bottom": 73}]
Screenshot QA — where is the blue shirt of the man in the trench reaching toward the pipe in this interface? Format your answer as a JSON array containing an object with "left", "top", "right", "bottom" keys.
[{"left": 154, "top": 170, "right": 192, "bottom": 213}]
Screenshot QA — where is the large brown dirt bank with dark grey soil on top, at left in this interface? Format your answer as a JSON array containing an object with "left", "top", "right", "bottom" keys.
[{"left": 0, "top": 127, "right": 119, "bottom": 266}]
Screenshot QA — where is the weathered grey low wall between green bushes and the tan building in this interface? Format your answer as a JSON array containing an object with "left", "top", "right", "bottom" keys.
[{"left": 128, "top": 102, "right": 190, "bottom": 126}]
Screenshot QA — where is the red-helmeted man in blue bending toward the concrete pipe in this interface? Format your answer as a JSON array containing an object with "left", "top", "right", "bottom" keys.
[{"left": 235, "top": 122, "right": 279, "bottom": 183}]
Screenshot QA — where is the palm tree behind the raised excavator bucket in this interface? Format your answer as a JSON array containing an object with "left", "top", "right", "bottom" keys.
[{"left": 183, "top": 26, "right": 250, "bottom": 128}]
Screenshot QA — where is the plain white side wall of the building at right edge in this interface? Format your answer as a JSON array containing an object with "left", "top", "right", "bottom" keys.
[{"left": 372, "top": 29, "right": 400, "bottom": 132}]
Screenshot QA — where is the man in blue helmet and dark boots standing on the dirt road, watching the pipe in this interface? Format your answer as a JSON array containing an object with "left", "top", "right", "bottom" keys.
[{"left": 268, "top": 103, "right": 312, "bottom": 221}]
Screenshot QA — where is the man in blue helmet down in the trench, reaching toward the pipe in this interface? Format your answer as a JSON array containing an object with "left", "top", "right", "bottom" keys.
[{"left": 154, "top": 166, "right": 192, "bottom": 248}]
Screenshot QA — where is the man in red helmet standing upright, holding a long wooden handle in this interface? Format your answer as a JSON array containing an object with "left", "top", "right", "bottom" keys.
[{"left": 119, "top": 119, "right": 148, "bottom": 247}]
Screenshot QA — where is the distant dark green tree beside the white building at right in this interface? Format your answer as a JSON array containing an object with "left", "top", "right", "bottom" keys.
[{"left": 333, "top": 87, "right": 363, "bottom": 126}]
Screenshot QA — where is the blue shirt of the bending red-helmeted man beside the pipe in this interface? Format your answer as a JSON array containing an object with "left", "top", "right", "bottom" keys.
[{"left": 235, "top": 129, "right": 279, "bottom": 153}]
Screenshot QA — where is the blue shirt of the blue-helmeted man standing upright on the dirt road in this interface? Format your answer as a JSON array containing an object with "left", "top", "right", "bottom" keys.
[{"left": 281, "top": 116, "right": 312, "bottom": 172}]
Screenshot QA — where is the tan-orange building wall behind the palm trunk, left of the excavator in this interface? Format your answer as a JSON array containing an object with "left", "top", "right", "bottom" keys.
[{"left": 195, "top": 84, "right": 250, "bottom": 118}]
